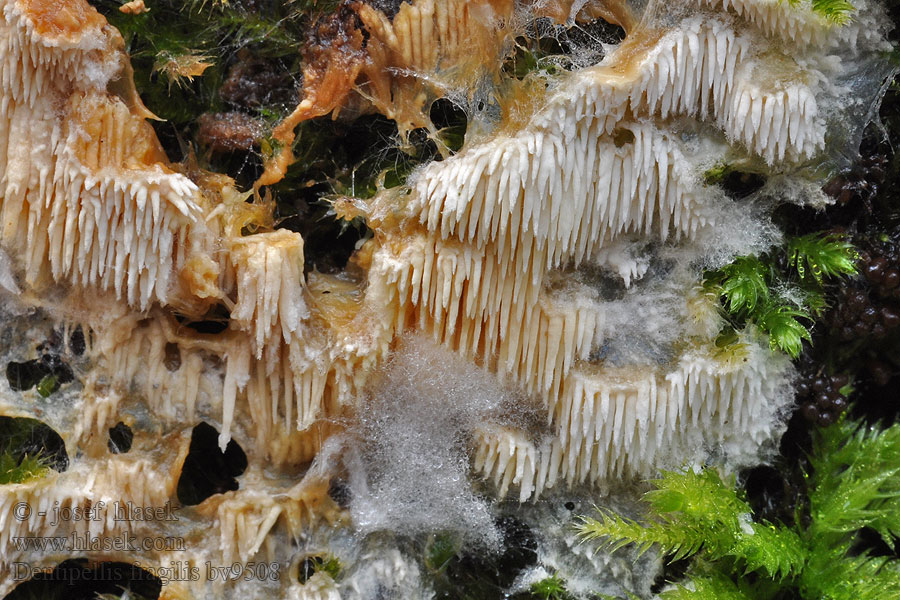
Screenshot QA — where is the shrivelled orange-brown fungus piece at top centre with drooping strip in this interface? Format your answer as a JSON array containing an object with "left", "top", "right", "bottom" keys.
[{"left": 255, "top": 0, "right": 514, "bottom": 188}]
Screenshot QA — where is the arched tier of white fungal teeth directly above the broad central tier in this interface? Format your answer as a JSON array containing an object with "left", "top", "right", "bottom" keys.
[{"left": 532, "top": 18, "right": 824, "bottom": 163}]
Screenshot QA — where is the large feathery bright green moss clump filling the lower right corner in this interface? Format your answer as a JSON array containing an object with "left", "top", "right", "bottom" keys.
[{"left": 580, "top": 421, "right": 900, "bottom": 600}]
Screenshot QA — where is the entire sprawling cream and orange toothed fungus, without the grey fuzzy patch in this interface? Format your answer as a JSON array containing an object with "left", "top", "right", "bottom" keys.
[{"left": 0, "top": 0, "right": 882, "bottom": 597}]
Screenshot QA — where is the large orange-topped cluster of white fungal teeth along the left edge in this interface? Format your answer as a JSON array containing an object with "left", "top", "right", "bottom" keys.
[{"left": 0, "top": 23, "right": 199, "bottom": 309}]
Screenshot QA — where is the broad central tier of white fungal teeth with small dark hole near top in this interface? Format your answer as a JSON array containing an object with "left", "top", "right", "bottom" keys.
[{"left": 412, "top": 119, "right": 710, "bottom": 269}]
